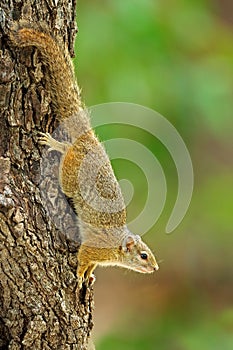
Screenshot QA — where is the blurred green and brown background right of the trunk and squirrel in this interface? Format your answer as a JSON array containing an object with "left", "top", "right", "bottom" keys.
[{"left": 75, "top": 0, "right": 233, "bottom": 350}]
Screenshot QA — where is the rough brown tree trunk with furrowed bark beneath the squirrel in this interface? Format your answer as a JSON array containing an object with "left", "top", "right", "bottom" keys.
[{"left": 0, "top": 0, "right": 93, "bottom": 350}]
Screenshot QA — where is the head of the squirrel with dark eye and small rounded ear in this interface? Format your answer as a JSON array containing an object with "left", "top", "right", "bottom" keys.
[{"left": 120, "top": 233, "right": 159, "bottom": 273}]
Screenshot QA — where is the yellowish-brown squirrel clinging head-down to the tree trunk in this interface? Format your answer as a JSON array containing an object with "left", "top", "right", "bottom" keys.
[{"left": 10, "top": 22, "right": 159, "bottom": 288}]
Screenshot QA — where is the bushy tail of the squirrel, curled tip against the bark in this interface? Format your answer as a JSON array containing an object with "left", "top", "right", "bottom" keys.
[{"left": 10, "top": 22, "right": 82, "bottom": 120}]
